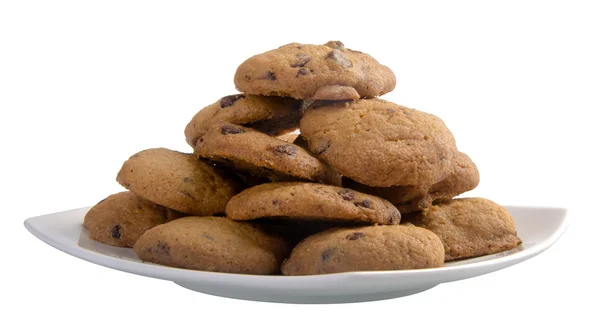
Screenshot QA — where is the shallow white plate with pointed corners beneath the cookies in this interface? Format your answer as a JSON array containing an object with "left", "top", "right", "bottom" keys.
[{"left": 25, "top": 206, "right": 567, "bottom": 303}]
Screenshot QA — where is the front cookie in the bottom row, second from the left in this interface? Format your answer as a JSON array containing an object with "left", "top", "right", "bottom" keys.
[{"left": 133, "top": 216, "right": 288, "bottom": 274}]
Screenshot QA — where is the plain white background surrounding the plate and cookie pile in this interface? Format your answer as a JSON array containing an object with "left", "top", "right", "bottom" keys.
[{"left": 0, "top": 1, "right": 600, "bottom": 335}]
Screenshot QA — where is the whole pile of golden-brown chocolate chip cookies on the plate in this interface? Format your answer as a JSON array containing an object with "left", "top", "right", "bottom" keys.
[{"left": 83, "top": 41, "right": 521, "bottom": 275}]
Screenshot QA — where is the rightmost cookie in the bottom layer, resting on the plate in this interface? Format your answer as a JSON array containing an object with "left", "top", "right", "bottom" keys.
[{"left": 414, "top": 198, "right": 521, "bottom": 261}]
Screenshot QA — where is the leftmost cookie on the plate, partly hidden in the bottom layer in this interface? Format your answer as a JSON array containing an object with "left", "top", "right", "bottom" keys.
[{"left": 83, "top": 191, "right": 183, "bottom": 247}]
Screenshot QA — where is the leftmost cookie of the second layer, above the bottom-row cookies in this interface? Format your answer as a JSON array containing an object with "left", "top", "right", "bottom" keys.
[{"left": 117, "top": 148, "right": 240, "bottom": 216}]
